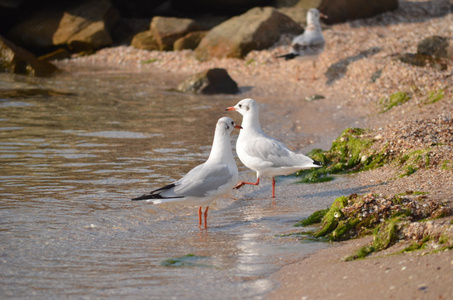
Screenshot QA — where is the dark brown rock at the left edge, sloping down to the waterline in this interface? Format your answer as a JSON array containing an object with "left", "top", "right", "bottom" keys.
[{"left": 0, "top": 36, "right": 58, "bottom": 76}]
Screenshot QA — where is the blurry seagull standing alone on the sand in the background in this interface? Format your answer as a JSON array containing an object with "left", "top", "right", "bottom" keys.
[{"left": 277, "top": 8, "right": 327, "bottom": 80}]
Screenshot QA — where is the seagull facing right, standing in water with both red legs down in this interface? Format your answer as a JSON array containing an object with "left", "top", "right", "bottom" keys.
[{"left": 132, "top": 117, "right": 242, "bottom": 229}]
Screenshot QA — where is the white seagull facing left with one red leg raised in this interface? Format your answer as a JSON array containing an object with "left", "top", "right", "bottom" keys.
[{"left": 226, "top": 98, "right": 322, "bottom": 198}]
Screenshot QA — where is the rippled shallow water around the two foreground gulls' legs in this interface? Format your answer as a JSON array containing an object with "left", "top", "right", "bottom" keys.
[{"left": 0, "top": 73, "right": 364, "bottom": 299}]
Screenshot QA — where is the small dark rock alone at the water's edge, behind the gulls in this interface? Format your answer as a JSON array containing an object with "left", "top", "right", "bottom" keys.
[{"left": 178, "top": 68, "right": 239, "bottom": 94}]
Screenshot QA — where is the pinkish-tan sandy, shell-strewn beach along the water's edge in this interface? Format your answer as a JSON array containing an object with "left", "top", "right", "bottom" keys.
[{"left": 53, "top": 1, "right": 453, "bottom": 299}]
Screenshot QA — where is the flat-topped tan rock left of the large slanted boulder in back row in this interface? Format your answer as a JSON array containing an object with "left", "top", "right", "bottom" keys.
[{"left": 150, "top": 16, "right": 201, "bottom": 51}]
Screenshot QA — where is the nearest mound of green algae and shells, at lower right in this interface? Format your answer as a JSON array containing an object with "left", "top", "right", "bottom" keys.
[{"left": 296, "top": 191, "right": 451, "bottom": 260}]
